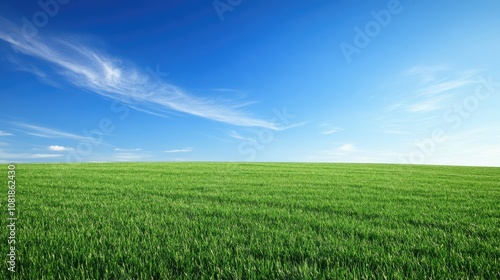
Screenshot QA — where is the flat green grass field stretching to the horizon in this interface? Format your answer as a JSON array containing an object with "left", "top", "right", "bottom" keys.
[{"left": 0, "top": 163, "right": 500, "bottom": 279}]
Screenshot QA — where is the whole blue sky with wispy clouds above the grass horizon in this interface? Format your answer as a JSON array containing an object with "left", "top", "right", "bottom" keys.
[{"left": 0, "top": 0, "right": 500, "bottom": 166}]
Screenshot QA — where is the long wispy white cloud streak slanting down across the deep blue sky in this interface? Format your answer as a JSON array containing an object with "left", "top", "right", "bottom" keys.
[{"left": 0, "top": 18, "right": 280, "bottom": 129}]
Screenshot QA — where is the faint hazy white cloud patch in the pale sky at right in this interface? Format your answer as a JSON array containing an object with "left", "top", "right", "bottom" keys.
[{"left": 375, "top": 66, "right": 485, "bottom": 135}]
